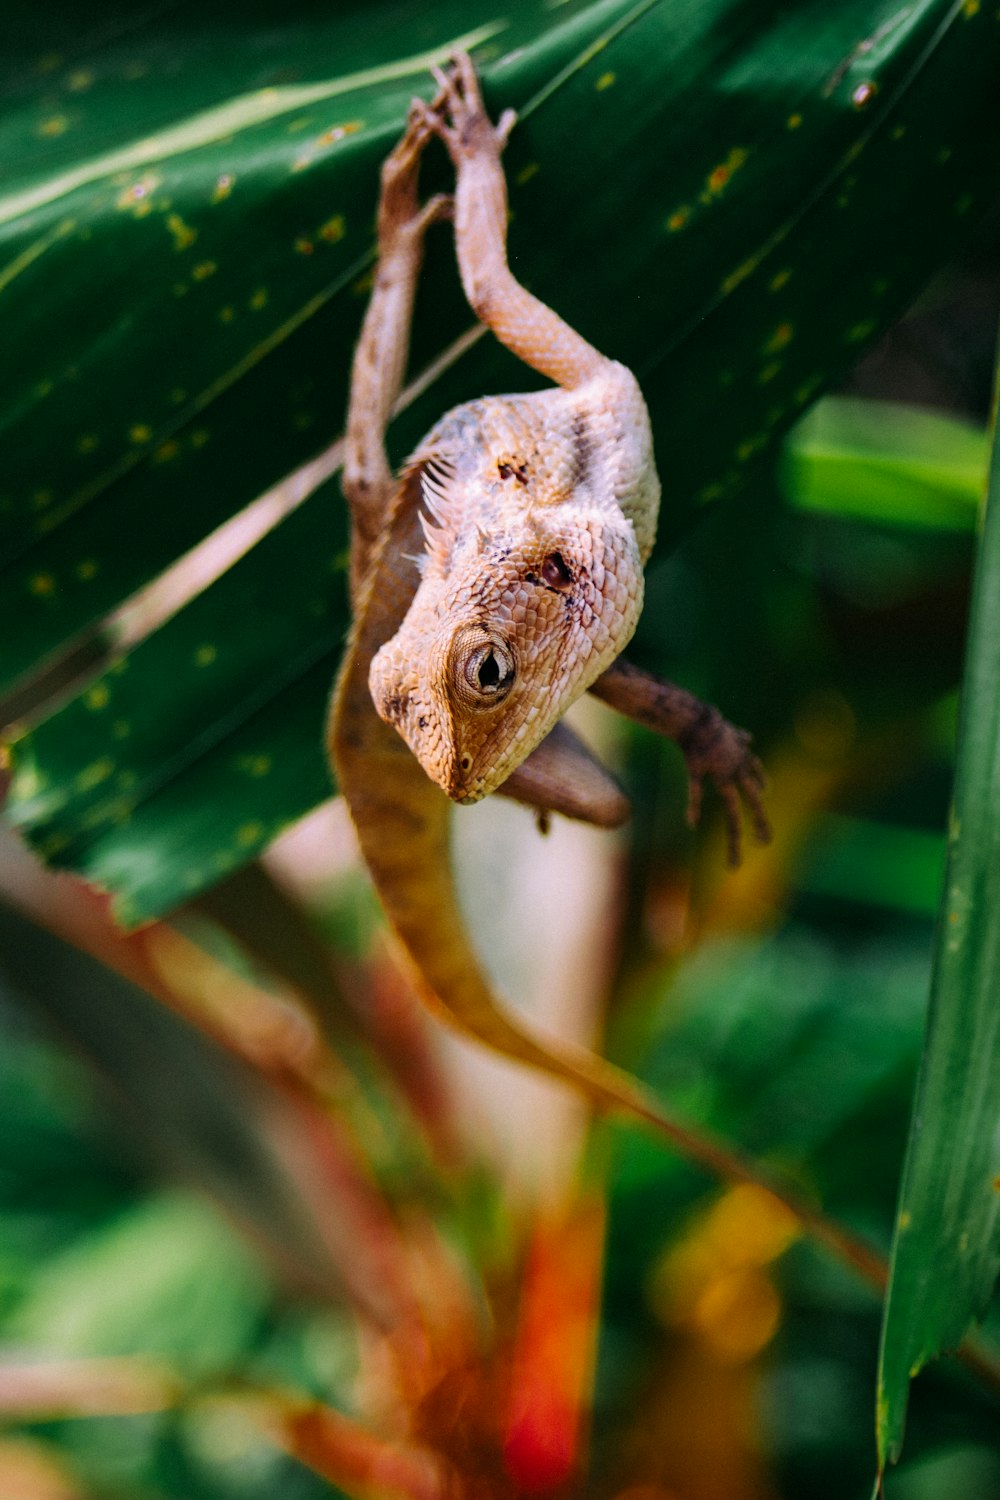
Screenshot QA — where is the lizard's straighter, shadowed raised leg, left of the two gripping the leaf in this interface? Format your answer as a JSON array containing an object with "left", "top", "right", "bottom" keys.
[{"left": 340, "top": 107, "right": 451, "bottom": 606}]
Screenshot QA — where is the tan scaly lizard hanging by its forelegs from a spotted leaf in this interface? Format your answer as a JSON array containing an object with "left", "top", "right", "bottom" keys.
[{"left": 327, "top": 53, "right": 769, "bottom": 1140}]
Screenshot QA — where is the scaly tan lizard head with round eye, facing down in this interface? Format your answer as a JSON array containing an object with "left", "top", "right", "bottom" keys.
[{"left": 369, "top": 506, "right": 643, "bottom": 803}]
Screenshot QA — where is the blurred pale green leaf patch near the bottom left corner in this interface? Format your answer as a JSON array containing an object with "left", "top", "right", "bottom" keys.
[{"left": 9, "top": 1194, "right": 270, "bottom": 1379}]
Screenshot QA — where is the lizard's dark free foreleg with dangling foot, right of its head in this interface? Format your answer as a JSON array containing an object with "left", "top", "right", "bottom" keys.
[{"left": 591, "top": 657, "right": 771, "bottom": 867}]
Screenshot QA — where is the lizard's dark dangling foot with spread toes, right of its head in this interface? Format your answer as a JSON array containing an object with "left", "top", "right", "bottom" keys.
[{"left": 676, "top": 704, "right": 771, "bottom": 870}]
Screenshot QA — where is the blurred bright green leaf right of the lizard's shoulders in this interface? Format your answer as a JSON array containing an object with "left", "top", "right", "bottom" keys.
[{"left": 781, "top": 396, "right": 990, "bottom": 531}]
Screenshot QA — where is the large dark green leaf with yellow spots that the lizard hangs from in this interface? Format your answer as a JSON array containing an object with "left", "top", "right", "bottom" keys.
[{"left": 0, "top": 0, "right": 1000, "bottom": 920}]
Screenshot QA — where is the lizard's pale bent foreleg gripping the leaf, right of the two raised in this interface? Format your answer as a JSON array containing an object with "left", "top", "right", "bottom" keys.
[{"left": 420, "top": 53, "right": 610, "bottom": 389}]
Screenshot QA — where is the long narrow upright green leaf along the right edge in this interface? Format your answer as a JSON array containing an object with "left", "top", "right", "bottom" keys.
[{"left": 879, "top": 331, "right": 1000, "bottom": 1464}]
